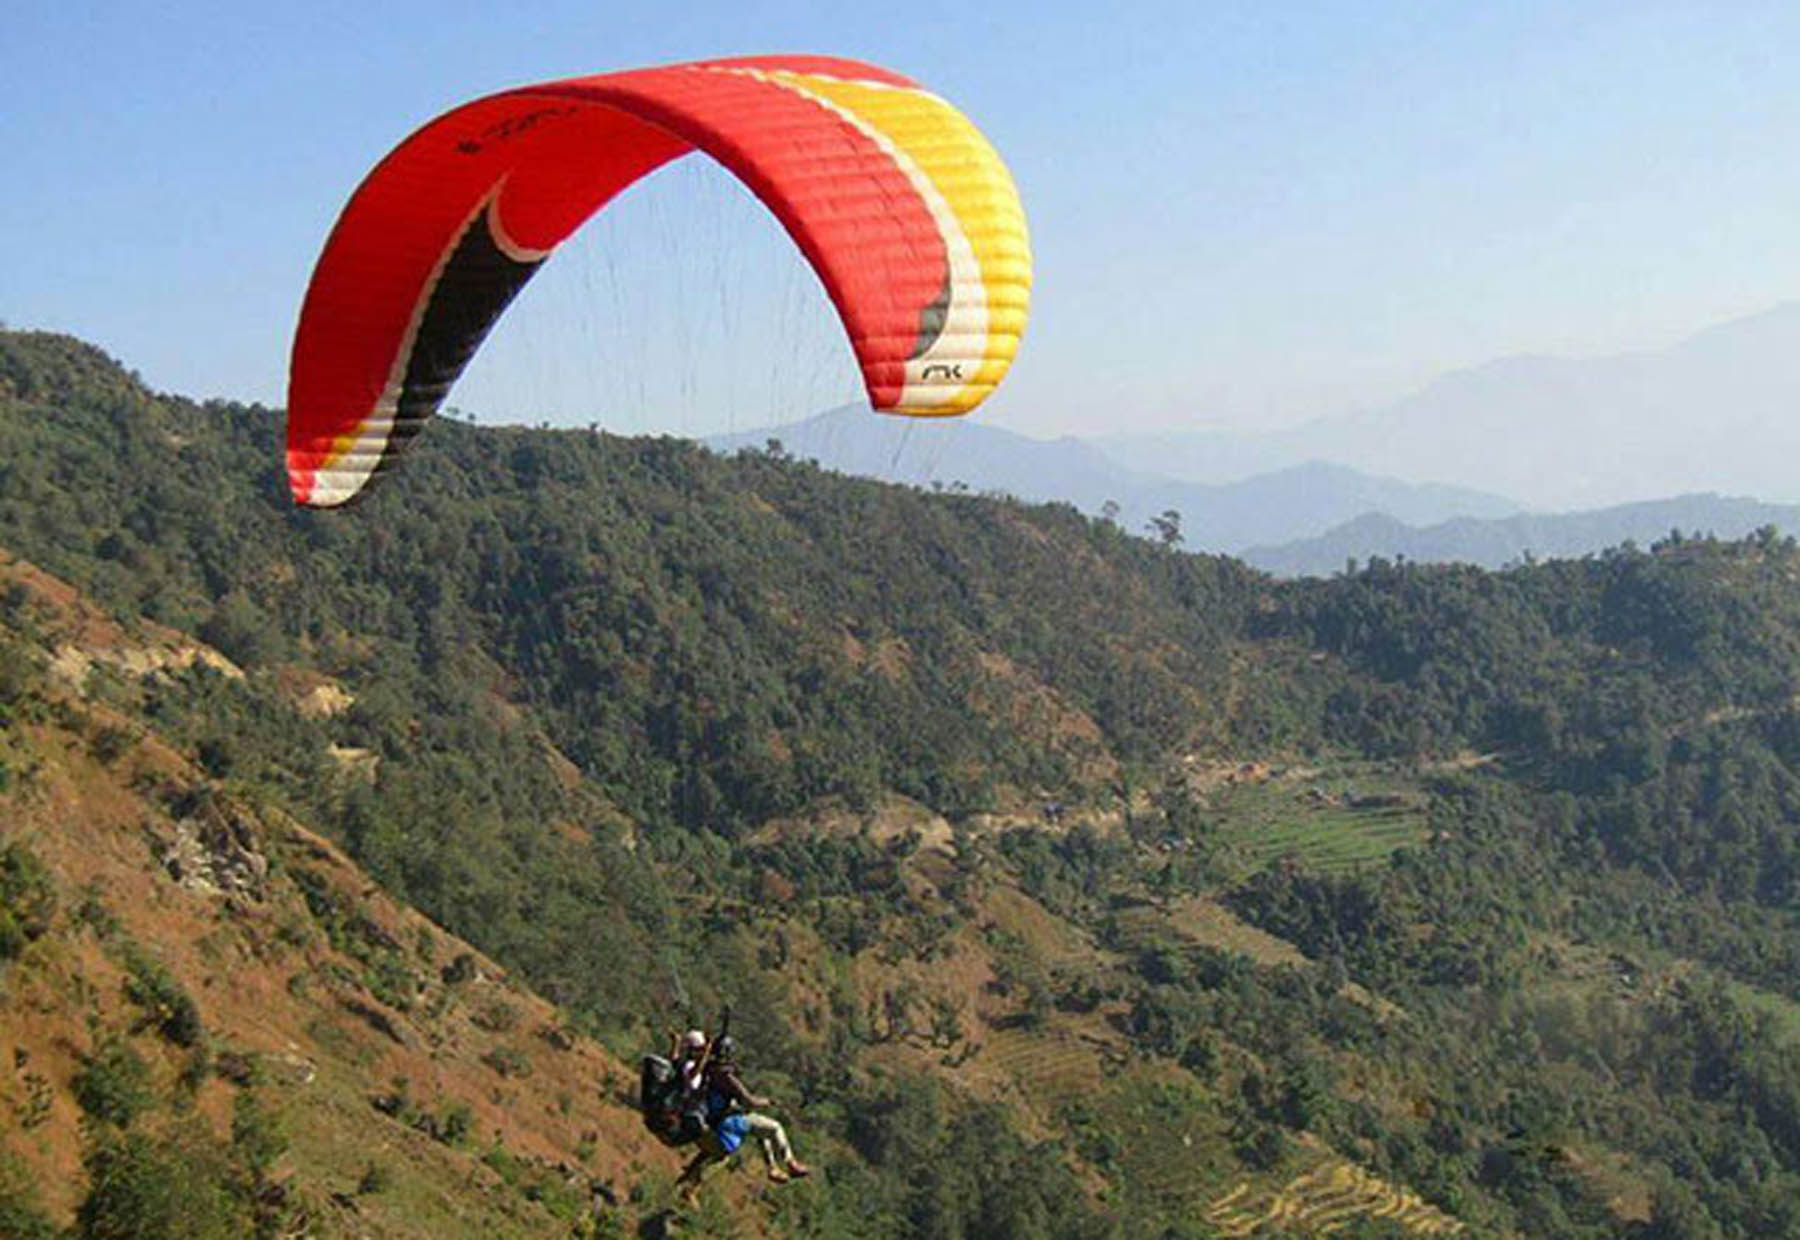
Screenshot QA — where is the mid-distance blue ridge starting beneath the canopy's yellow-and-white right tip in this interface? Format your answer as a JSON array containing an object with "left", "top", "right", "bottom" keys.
[{"left": 706, "top": 407, "right": 1519, "bottom": 553}]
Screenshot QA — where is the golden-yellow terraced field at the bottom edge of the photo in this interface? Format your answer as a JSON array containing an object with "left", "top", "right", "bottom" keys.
[{"left": 1204, "top": 1159, "right": 1463, "bottom": 1238}]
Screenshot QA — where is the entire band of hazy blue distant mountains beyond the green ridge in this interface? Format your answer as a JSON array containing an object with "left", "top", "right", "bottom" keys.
[{"left": 707, "top": 302, "right": 1800, "bottom": 574}]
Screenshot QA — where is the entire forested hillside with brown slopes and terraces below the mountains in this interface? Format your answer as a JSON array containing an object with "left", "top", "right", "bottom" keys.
[{"left": 0, "top": 333, "right": 1800, "bottom": 1240}]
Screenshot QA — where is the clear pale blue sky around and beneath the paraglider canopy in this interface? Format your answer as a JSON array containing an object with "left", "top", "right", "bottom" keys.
[{"left": 0, "top": 0, "right": 1800, "bottom": 436}]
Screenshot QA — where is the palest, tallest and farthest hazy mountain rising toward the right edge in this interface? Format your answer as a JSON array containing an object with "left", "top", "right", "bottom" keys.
[{"left": 1096, "top": 302, "right": 1800, "bottom": 511}]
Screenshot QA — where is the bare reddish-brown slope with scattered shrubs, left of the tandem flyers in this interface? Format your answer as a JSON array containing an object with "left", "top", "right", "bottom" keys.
[{"left": 0, "top": 560, "right": 777, "bottom": 1240}]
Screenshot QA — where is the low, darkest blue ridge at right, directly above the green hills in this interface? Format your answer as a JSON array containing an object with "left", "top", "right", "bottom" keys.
[{"left": 1240, "top": 495, "right": 1800, "bottom": 576}]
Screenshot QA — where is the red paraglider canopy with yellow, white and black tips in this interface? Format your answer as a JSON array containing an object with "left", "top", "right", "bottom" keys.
[{"left": 288, "top": 56, "right": 1031, "bottom": 508}]
